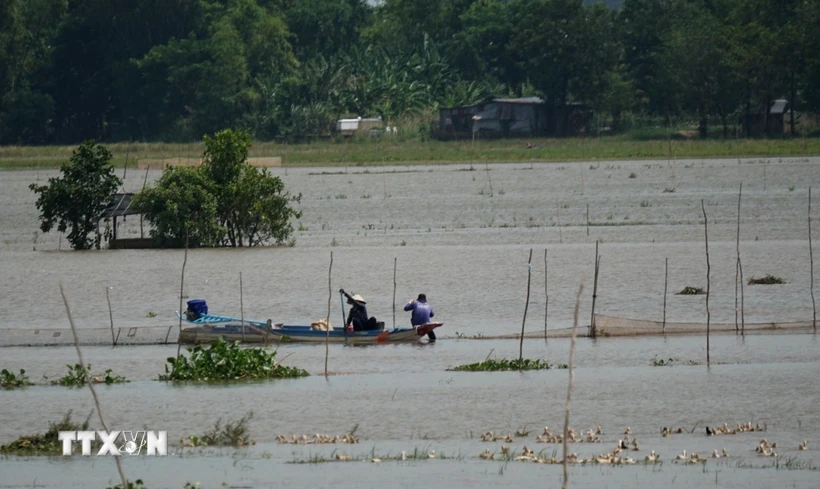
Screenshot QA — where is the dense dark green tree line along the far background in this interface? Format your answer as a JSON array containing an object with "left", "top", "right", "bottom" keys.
[{"left": 0, "top": 0, "right": 820, "bottom": 144}]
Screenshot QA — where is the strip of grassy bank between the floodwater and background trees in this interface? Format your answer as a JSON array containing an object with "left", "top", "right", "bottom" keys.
[{"left": 0, "top": 136, "right": 820, "bottom": 169}]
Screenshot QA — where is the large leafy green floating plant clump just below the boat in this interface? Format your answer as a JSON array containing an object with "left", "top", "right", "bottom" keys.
[{"left": 157, "top": 339, "right": 308, "bottom": 381}]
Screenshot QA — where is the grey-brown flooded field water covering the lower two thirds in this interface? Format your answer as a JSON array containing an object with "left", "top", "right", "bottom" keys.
[{"left": 0, "top": 158, "right": 820, "bottom": 489}]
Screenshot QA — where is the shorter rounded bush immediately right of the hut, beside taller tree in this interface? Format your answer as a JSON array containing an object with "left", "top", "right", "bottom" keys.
[{"left": 132, "top": 166, "right": 225, "bottom": 248}]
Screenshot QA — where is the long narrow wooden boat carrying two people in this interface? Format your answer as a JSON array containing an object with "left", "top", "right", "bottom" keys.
[{"left": 177, "top": 312, "right": 443, "bottom": 345}]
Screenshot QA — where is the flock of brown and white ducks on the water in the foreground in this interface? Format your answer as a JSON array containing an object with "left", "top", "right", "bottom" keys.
[{"left": 276, "top": 423, "right": 809, "bottom": 465}]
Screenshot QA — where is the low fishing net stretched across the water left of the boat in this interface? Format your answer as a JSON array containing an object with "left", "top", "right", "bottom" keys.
[{"left": 0, "top": 325, "right": 179, "bottom": 347}]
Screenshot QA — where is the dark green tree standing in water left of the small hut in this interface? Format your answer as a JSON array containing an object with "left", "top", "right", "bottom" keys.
[{"left": 29, "top": 141, "right": 122, "bottom": 250}]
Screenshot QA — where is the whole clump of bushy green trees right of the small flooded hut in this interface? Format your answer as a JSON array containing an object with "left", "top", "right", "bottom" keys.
[{"left": 133, "top": 129, "right": 301, "bottom": 247}]
